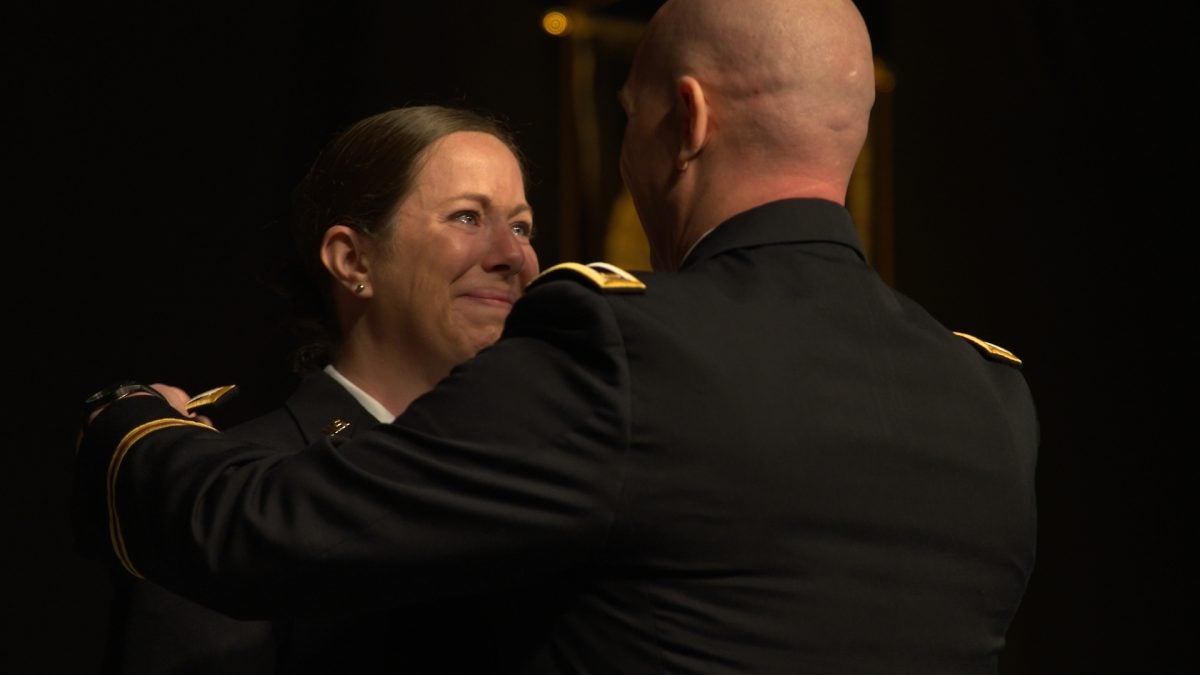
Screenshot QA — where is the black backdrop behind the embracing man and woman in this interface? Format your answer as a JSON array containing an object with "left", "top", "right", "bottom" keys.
[{"left": 0, "top": 0, "right": 1198, "bottom": 674}]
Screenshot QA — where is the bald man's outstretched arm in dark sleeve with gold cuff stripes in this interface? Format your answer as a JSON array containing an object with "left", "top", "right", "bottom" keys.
[{"left": 76, "top": 277, "right": 629, "bottom": 617}]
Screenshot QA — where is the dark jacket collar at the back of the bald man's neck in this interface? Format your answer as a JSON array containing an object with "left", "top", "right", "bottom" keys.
[{"left": 680, "top": 199, "right": 866, "bottom": 269}]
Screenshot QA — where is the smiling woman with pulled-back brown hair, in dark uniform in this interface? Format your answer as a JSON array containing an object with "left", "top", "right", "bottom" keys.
[{"left": 107, "top": 106, "right": 538, "bottom": 674}]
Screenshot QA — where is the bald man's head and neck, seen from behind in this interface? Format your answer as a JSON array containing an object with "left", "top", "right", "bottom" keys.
[{"left": 620, "top": 0, "right": 875, "bottom": 269}]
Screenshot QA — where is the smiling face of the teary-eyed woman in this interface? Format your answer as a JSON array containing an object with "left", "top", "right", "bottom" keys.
[{"left": 367, "top": 131, "right": 538, "bottom": 371}]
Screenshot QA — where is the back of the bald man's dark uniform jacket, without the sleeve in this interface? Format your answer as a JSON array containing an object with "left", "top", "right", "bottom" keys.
[{"left": 511, "top": 201, "right": 1037, "bottom": 674}]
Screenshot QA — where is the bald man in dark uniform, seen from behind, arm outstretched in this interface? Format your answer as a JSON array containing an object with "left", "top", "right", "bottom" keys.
[{"left": 76, "top": 0, "right": 1038, "bottom": 675}]
